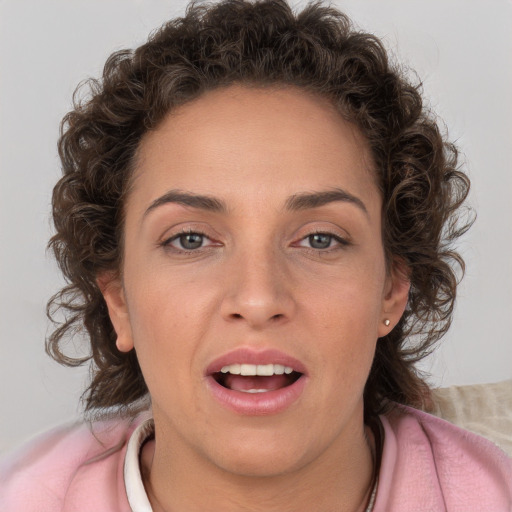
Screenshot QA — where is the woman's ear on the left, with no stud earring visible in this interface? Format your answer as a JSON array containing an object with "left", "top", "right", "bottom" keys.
[{"left": 96, "top": 273, "right": 133, "bottom": 352}]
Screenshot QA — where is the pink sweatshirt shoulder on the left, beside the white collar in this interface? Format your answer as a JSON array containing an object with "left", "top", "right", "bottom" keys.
[{"left": 0, "top": 419, "right": 148, "bottom": 512}]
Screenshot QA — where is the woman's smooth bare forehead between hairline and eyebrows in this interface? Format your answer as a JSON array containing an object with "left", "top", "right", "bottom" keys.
[{"left": 129, "top": 85, "right": 377, "bottom": 214}]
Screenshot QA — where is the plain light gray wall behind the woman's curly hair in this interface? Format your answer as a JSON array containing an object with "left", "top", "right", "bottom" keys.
[{"left": 0, "top": 0, "right": 512, "bottom": 451}]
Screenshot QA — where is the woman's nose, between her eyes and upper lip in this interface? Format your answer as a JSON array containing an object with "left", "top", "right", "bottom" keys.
[{"left": 221, "top": 243, "right": 296, "bottom": 330}]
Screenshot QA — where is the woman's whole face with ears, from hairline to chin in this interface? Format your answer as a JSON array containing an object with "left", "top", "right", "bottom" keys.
[{"left": 105, "top": 85, "right": 408, "bottom": 475}]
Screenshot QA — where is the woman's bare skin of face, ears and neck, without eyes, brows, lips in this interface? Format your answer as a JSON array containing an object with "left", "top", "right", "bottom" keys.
[{"left": 100, "top": 85, "right": 409, "bottom": 512}]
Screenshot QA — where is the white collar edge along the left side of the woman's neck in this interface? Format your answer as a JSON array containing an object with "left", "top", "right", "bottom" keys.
[{"left": 124, "top": 418, "right": 155, "bottom": 512}]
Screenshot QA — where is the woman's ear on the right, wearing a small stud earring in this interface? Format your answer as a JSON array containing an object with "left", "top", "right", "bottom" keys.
[{"left": 378, "top": 258, "right": 411, "bottom": 338}]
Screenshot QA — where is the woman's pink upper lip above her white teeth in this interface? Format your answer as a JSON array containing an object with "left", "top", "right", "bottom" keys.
[{"left": 206, "top": 347, "right": 307, "bottom": 375}]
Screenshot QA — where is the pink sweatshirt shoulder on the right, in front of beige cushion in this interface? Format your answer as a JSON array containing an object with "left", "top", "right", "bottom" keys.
[{"left": 376, "top": 406, "right": 512, "bottom": 512}]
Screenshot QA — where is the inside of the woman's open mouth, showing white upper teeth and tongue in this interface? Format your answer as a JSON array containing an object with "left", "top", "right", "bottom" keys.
[{"left": 212, "top": 364, "right": 302, "bottom": 393}]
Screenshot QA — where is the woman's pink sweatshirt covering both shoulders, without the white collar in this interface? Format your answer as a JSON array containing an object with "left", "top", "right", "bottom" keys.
[{"left": 0, "top": 407, "right": 512, "bottom": 512}]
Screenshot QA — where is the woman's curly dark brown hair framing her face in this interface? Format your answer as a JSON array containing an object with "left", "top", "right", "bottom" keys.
[{"left": 46, "top": 0, "right": 470, "bottom": 418}]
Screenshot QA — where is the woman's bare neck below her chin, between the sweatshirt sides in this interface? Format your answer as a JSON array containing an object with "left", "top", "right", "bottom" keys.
[{"left": 141, "top": 416, "right": 375, "bottom": 512}]
